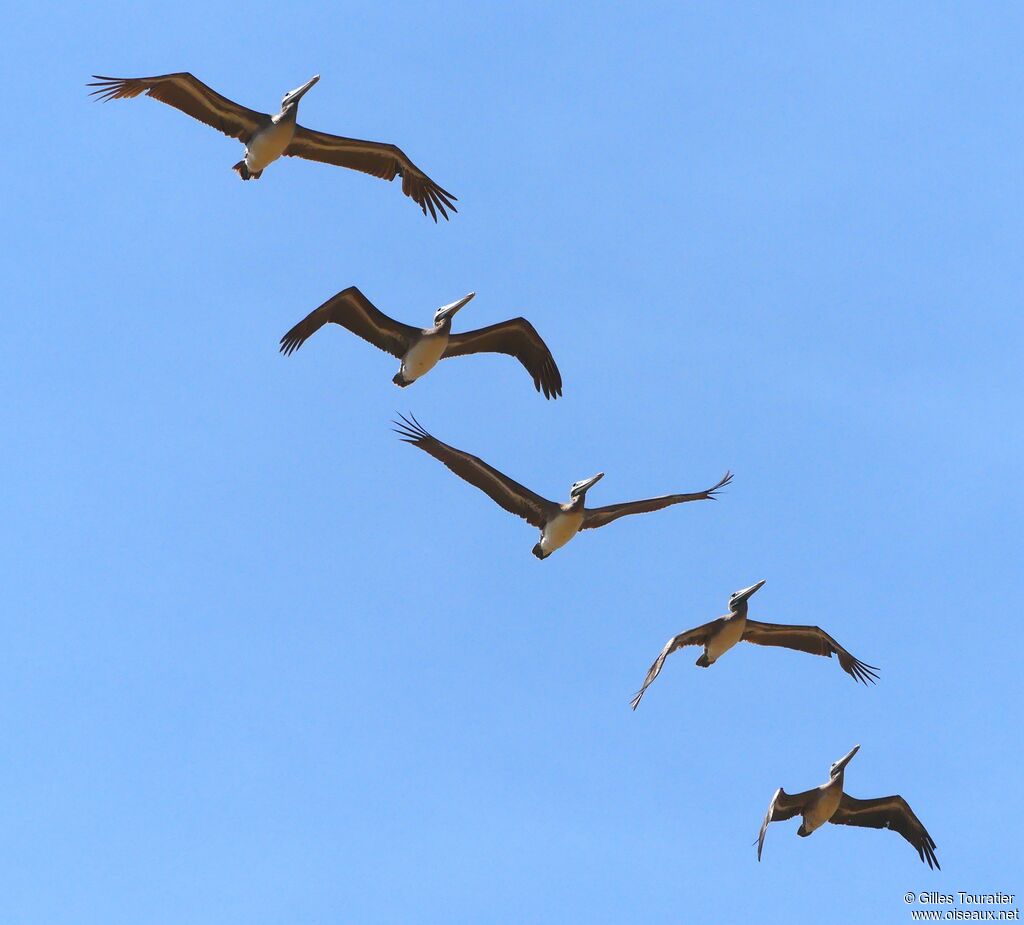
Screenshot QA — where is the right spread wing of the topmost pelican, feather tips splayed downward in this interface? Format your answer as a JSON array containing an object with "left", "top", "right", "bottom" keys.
[{"left": 285, "top": 125, "right": 459, "bottom": 221}]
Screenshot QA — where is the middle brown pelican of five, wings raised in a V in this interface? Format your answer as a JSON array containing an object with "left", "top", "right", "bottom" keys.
[{"left": 394, "top": 415, "right": 732, "bottom": 559}]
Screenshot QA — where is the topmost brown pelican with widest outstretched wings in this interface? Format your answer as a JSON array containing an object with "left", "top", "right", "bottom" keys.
[{"left": 88, "top": 72, "right": 458, "bottom": 221}]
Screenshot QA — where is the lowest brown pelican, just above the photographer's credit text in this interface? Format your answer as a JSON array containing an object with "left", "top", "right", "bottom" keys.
[{"left": 758, "top": 745, "right": 939, "bottom": 869}]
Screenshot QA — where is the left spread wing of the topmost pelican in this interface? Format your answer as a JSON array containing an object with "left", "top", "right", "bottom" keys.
[{"left": 88, "top": 72, "right": 270, "bottom": 141}]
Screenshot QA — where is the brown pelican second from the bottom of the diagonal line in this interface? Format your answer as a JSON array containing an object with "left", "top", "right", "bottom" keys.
[{"left": 630, "top": 579, "right": 879, "bottom": 710}]
